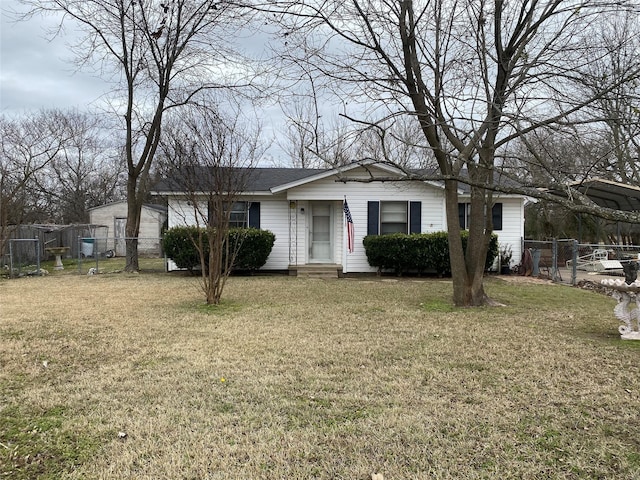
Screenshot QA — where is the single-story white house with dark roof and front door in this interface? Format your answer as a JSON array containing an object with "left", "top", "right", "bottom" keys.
[{"left": 154, "top": 162, "right": 525, "bottom": 273}]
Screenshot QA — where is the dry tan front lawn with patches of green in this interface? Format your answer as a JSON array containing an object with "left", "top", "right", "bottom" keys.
[{"left": 0, "top": 275, "right": 640, "bottom": 479}]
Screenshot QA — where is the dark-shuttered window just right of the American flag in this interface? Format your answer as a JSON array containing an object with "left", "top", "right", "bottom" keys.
[{"left": 367, "top": 201, "right": 422, "bottom": 235}]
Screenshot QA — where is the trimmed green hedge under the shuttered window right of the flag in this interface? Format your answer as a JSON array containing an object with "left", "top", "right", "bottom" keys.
[{"left": 363, "top": 231, "right": 498, "bottom": 275}]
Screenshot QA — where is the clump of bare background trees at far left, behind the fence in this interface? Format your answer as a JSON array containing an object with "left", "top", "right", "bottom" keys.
[{"left": 0, "top": 110, "right": 122, "bottom": 255}]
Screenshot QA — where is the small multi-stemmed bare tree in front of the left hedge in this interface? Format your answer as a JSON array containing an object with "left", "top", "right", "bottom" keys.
[{"left": 162, "top": 108, "right": 263, "bottom": 305}]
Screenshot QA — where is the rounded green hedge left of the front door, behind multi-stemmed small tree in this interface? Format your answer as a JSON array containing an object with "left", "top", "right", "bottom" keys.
[{"left": 162, "top": 226, "right": 276, "bottom": 271}]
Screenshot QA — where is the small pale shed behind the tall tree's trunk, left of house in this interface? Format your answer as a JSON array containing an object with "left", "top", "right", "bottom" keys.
[{"left": 89, "top": 200, "right": 167, "bottom": 257}]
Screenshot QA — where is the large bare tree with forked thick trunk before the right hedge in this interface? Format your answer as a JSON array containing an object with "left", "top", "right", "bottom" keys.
[{"left": 265, "top": 0, "right": 638, "bottom": 306}]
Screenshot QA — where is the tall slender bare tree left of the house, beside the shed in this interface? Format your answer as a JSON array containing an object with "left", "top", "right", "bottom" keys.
[{"left": 20, "top": 0, "right": 262, "bottom": 271}]
